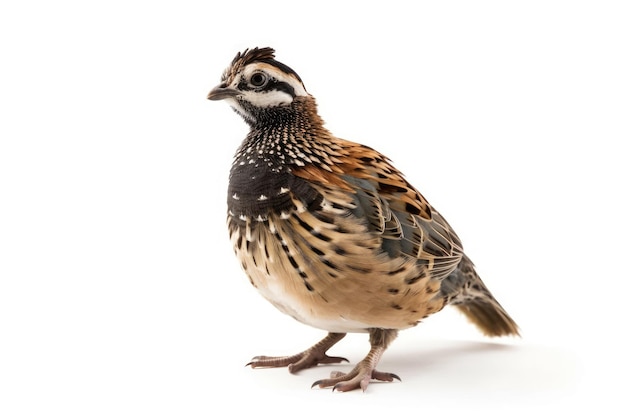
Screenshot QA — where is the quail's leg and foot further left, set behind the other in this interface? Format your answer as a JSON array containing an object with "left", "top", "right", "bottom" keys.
[{"left": 248, "top": 333, "right": 349, "bottom": 373}]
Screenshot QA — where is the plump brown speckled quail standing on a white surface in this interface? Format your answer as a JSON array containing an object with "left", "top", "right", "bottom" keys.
[{"left": 207, "top": 47, "right": 519, "bottom": 391}]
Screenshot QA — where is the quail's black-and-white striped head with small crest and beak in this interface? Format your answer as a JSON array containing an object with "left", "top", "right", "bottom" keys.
[{"left": 207, "top": 48, "right": 309, "bottom": 124}]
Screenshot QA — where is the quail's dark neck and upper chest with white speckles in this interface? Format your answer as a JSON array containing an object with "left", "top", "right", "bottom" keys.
[{"left": 228, "top": 97, "right": 333, "bottom": 224}]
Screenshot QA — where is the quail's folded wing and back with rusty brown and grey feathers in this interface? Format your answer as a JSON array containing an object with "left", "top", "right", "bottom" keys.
[{"left": 293, "top": 139, "right": 463, "bottom": 279}]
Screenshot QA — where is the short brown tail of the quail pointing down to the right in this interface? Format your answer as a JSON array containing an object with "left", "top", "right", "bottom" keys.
[{"left": 442, "top": 256, "right": 520, "bottom": 336}]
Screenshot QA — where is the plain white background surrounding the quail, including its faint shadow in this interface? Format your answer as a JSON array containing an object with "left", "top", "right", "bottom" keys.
[{"left": 0, "top": 0, "right": 626, "bottom": 416}]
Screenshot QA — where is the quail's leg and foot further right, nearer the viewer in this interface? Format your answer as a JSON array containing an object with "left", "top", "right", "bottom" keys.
[{"left": 313, "top": 329, "right": 400, "bottom": 391}]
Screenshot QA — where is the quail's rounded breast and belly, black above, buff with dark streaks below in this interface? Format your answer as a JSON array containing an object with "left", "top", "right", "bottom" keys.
[{"left": 228, "top": 165, "right": 445, "bottom": 332}]
